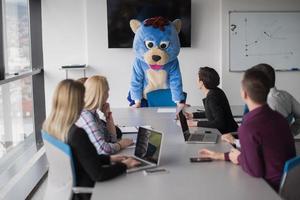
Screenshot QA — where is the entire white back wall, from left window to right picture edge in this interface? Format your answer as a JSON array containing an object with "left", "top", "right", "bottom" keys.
[{"left": 42, "top": 0, "right": 300, "bottom": 109}]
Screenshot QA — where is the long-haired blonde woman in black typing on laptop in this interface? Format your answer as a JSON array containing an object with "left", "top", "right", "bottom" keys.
[{"left": 43, "top": 80, "right": 139, "bottom": 197}]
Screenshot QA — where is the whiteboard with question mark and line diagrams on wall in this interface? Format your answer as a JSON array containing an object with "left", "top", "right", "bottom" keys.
[{"left": 229, "top": 11, "right": 300, "bottom": 71}]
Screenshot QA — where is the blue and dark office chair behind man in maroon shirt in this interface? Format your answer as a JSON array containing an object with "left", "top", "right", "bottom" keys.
[{"left": 279, "top": 156, "right": 300, "bottom": 200}]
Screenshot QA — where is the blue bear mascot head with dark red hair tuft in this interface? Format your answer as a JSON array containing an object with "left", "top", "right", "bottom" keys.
[{"left": 130, "top": 17, "right": 181, "bottom": 70}]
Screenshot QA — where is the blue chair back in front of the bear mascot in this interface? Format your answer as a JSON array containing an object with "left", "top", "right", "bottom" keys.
[{"left": 147, "top": 89, "right": 187, "bottom": 107}]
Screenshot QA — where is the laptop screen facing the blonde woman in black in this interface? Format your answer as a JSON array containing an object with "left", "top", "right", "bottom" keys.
[{"left": 134, "top": 127, "right": 162, "bottom": 164}]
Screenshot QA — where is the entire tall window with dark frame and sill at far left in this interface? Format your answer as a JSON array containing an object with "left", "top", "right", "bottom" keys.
[{"left": 0, "top": 0, "right": 47, "bottom": 195}]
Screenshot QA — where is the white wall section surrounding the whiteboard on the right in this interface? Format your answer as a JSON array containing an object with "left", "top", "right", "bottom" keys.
[{"left": 221, "top": 0, "right": 300, "bottom": 105}]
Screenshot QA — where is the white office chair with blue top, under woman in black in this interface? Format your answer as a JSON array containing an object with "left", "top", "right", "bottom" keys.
[{"left": 42, "top": 131, "right": 93, "bottom": 200}]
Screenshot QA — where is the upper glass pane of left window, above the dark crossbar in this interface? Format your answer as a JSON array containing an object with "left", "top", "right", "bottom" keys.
[{"left": 3, "top": 0, "right": 31, "bottom": 74}]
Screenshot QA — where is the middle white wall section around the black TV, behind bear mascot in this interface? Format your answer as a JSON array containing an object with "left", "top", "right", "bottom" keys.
[{"left": 86, "top": 0, "right": 220, "bottom": 107}]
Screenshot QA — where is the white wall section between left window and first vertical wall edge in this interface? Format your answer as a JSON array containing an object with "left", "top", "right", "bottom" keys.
[{"left": 42, "top": 0, "right": 87, "bottom": 113}]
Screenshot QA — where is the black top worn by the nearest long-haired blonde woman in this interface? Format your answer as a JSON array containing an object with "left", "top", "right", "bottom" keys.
[{"left": 68, "top": 125, "right": 127, "bottom": 199}]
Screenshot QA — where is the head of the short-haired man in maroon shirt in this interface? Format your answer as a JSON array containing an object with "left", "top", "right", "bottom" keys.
[{"left": 241, "top": 68, "right": 270, "bottom": 108}]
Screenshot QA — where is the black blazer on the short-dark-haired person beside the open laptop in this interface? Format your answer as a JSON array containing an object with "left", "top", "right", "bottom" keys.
[{"left": 193, "top": 88, "right": 238, "bottom": 134}]
